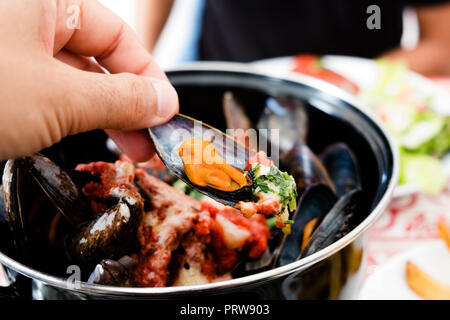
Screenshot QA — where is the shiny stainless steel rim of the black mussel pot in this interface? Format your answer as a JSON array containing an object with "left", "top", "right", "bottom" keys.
[{"left": 0, "top": 62, "right": 399, "bottom": 298}]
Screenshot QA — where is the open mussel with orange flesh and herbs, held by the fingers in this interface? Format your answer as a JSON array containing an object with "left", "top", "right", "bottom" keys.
[{"left": 149, "top": 114, "right": 297, "bottom": 233}]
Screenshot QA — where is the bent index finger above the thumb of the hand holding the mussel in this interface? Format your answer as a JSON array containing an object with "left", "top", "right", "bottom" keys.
[{"left": 55, "top": 0, "right": 167, "bottom": 79}]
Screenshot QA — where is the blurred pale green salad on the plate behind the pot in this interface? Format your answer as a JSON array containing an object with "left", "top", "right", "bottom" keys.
[{"left": 359, "top": 59, "right": 450, "bottom": 194}]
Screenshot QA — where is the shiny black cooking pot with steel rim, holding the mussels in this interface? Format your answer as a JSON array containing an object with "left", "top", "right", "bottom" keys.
[{"left": 0, "top": 63, "right": 398, "bottom": 299}]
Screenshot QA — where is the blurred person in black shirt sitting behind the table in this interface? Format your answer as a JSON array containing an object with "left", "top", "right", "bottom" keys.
[{"left": 137, "top": 0, "right": 450, "bottom": 75}]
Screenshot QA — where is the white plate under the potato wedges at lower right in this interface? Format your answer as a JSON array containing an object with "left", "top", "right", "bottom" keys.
[{"left": 358, "top": 240, "right": 450, "bottom": 300}]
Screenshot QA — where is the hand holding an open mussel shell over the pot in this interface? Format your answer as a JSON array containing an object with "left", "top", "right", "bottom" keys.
[{"left": 0, "top": 0, "right": 178, "bottom": 161}]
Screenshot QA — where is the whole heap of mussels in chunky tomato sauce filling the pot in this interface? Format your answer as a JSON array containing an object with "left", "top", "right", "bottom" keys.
[{"left": 0, "top": 90, "right": 363, "bottom": 287}]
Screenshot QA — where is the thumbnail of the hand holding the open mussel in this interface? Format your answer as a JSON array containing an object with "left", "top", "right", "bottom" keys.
[{"left": 153, "top": 80, "right": 178, "bottom": 120}]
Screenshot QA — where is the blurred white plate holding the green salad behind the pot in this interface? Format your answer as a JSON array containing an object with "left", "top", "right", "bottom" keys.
[{"left": 251, "top": 55, "right": 450, "bottom": 197}]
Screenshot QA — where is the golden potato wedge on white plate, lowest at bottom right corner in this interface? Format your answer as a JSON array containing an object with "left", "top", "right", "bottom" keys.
[{"left": 406, "top": 261, "right": 450, "bottom": 300}]
